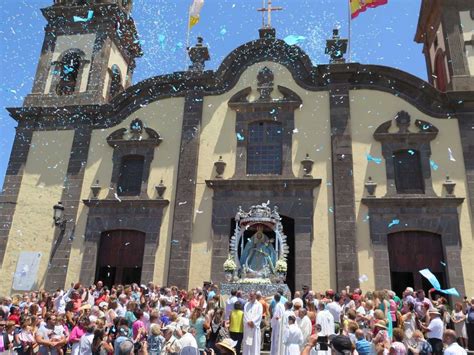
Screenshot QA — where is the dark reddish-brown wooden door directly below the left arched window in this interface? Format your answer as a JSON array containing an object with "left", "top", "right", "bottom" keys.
[{"left": 96, "top": 230, "right": 145, "bottom": 287}]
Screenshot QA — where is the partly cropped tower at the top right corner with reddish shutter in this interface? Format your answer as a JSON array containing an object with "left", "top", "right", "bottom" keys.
[{"left": 415, "top": 0, "right": 474, "bottom": 91}]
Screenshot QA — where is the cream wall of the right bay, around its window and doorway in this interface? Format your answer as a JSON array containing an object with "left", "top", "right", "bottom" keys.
[{"left": 351, "top": 90, "right": 474, "bottom": 296}]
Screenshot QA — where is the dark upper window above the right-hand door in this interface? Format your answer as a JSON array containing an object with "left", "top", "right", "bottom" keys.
[{"left": 393, "top": 149, "right": 425, "bottom": 194}]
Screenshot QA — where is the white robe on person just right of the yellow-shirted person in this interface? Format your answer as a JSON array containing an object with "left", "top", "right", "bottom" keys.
[{"left": 242, "top": 301, "right": 263, "bottom": 355}]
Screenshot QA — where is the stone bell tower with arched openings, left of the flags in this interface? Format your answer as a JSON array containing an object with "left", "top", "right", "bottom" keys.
[{"left": 24, "top": 0, "right": 143, "bottom": 107}]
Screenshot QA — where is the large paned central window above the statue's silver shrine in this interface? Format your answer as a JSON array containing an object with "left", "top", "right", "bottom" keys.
[{"left": 247, "top": 122, "right": 283, "bottom": 174}]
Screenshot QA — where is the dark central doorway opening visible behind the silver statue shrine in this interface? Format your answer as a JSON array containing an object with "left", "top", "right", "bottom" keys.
[{"left": 229, "top": 215, "right": 296, "bottom": 293}]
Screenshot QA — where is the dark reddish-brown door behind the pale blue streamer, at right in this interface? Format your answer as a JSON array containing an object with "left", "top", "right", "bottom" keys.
[{"left": 388, "top": 231, "right": 446, "bottom": 295}]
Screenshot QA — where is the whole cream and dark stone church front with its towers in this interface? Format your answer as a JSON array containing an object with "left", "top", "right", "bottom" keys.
[{"left": 0, "top": 0, "right": 474, "bottom": 296}]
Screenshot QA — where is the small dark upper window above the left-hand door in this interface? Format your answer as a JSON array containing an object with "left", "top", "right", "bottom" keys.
[{"left": 117, "top": 155, "right": 145, "bottom": 196}]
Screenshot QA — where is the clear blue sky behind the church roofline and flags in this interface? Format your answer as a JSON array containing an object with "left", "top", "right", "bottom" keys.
[{"left": 0, "top": 0, "right": 426, "bottom": 186}]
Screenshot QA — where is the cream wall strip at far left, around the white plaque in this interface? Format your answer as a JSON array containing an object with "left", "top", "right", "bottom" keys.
[{"left": 0, "top": 131, "right": 73, "bottom": 294}]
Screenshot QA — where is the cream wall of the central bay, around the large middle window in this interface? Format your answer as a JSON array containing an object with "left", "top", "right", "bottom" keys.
[{"left": 189, "top": 62, "right": 335, "bottom": 289}]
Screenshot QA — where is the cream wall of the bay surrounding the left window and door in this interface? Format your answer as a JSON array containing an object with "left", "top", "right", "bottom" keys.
[{"left": 66, "top": 98, "right": 184, "bottom": 290}]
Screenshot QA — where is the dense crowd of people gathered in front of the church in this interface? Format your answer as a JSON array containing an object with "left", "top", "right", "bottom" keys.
[{"left": 0, "top": 281, "right": 474, "bottom": 355}]
